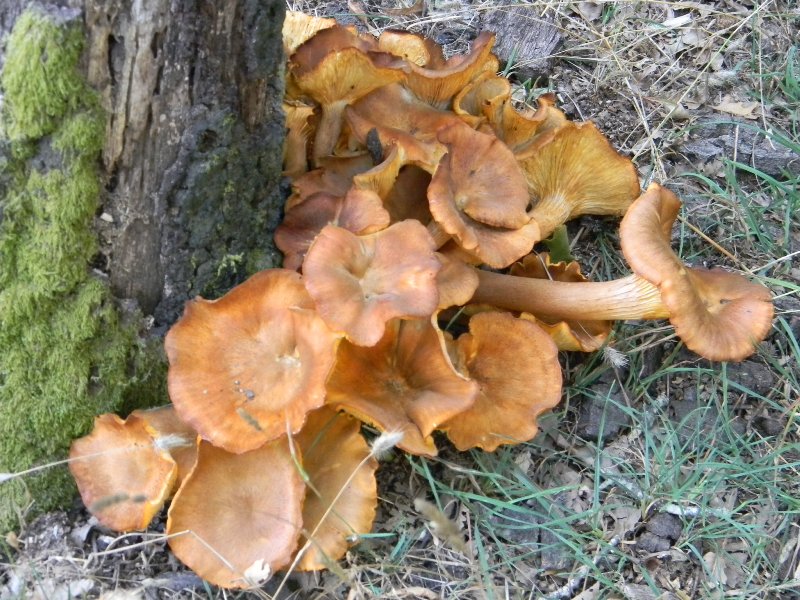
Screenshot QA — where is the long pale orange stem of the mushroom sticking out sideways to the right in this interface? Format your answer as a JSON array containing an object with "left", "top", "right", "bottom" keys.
[{"left": 471, "top": 270, "right": 669, "bottom": 321}]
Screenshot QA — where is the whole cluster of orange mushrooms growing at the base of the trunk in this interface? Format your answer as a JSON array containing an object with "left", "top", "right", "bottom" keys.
[{"left": 71, "top": 13, "right": 773, "bottom": 588}]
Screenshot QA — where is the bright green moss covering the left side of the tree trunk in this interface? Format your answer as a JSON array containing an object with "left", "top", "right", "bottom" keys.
[{"left": 0, "top": 10, "right": 166, "bottom": 531}]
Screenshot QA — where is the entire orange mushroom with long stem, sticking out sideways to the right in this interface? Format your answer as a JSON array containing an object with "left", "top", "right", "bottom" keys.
[{"left": 472, "top": 184, "right": 773, "bottom": 361}]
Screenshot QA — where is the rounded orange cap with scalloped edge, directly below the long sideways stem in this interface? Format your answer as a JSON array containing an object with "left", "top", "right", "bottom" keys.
[{"left": 442, "top": 312, "right": 561, "bottom": 452}]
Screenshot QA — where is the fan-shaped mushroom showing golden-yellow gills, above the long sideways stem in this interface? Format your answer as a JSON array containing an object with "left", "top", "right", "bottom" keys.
[{"left": 520, "top": 122, "right": 639, "bottom": 238}]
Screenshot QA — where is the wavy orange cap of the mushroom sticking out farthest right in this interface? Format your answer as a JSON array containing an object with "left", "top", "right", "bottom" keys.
[{"left": 620, "top": 183, "right": 773, "bottom": 361}]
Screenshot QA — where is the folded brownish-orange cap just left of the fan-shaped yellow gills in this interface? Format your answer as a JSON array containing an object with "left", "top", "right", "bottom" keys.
[{"left": 428, "top": 123, "right": 539, "bottom": 268}]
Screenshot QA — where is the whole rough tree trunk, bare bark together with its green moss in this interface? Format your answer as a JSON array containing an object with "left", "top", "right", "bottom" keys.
[{"left": 0, "top": 0, "right": 284, "bottom": 530}]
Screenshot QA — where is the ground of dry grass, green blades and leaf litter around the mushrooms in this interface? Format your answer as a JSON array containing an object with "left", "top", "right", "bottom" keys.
[{"left": 0, "top": 0, "right": 800, "bottom": 600}]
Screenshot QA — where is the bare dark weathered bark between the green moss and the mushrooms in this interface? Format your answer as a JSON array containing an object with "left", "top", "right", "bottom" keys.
[{"left": 85, "top": 0, "right": 283, "bottom": 324}]
